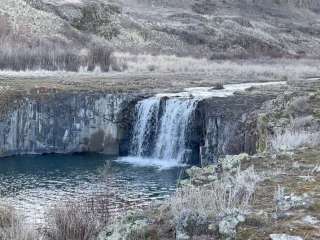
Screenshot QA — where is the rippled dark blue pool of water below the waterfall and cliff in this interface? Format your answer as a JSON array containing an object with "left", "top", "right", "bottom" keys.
[{"left": 0, "top": 154, "right": 181, "bottom": 223}]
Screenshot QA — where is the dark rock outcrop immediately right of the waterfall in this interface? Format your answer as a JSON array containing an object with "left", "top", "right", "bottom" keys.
[{"left": 198, "top": 94, "right": 275, "bottom": 165}]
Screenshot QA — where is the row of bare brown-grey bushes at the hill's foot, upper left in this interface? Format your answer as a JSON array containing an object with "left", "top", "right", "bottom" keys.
[{"left": 0, "top": 33, "right": 112, "bottom": 72}]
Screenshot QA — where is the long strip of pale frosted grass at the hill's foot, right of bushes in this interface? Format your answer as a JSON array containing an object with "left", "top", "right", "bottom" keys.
[{"left": 114, "top": 52, "right": 320, "bottom": 80}]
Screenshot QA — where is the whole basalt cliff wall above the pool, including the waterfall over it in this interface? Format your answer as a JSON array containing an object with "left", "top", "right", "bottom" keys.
[{"left": 0, "top": 85, "right": 282, "bottom": 164}]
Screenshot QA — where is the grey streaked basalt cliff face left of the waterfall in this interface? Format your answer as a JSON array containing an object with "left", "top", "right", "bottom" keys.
[{"left": 0, "top": 93, "right": 137, "bottom": 156}]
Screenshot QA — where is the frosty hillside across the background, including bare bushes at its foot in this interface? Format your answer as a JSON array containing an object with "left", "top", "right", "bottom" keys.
[{"left": 0, "top": 0, "right": 320, "bottom": 71}]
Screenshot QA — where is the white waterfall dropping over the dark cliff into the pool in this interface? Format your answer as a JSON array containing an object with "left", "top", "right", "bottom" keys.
[{"left": 131, "top": 97, "right": 197, "bottom": 162}]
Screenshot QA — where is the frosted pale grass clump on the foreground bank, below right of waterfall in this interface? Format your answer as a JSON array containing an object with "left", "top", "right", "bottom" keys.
[{"left": 169, "top": 167, "right": 260, "bottom": 221}]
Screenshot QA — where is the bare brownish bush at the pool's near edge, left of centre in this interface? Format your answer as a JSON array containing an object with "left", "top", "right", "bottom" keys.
[{"left": 45, "top": 196, "right": 109, "bottom": 240}]
